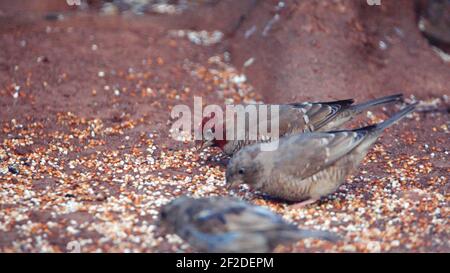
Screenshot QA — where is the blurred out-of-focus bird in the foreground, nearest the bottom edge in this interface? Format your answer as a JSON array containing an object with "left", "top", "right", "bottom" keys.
[{"left": 159, "top": 196, "right": 340, "bottom": 253}]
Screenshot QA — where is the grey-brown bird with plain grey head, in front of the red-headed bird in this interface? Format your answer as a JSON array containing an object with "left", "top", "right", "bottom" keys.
[{"left": 225, "top": 103, "right": 417, "bottom": 208}]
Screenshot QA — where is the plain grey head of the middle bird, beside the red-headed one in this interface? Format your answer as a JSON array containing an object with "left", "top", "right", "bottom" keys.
[{"left": 225, "top": 145, "right": 262, "bottom": 189}]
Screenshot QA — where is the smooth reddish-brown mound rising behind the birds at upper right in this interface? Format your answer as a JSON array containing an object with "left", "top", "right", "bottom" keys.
[{"left": 231, "top": 0, "right": 450, "bottom": 101}]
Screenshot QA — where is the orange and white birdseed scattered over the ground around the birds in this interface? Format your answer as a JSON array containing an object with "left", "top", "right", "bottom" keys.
[{"left": 0, "top": 7, "right": 450, "bottom": 252}]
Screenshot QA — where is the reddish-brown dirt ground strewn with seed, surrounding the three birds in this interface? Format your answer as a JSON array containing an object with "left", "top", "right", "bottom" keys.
[{"left": 0, "top": 0, "right": 450, "bottom": 252}]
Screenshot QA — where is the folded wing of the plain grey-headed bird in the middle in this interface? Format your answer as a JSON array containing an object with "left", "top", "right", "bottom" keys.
[{"left": 273, "top": 130, "right": 367, "bottom": 179}]
